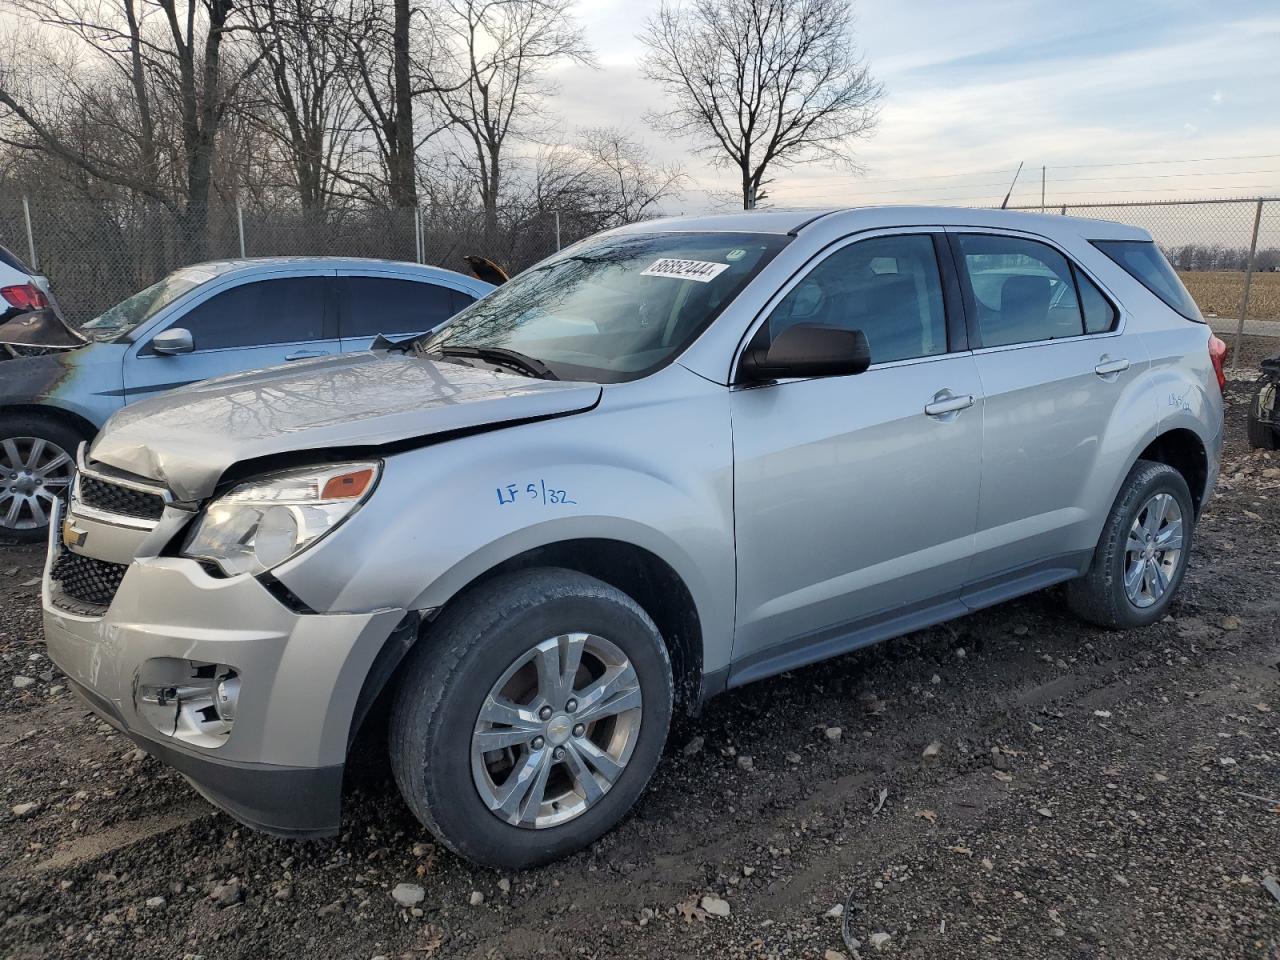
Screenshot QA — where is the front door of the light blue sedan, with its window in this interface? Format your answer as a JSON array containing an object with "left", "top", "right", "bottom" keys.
[{"left": 124, "top": 275, "right": 338, "bottom": 402}]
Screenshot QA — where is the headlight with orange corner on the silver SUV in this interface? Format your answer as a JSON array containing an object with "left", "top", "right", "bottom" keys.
[{"left": 182, "top": 461, "right": 383, "bottom": 576}]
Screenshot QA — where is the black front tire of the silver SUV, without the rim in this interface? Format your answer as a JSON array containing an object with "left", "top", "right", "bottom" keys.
[{"left": 389, "top": 568, "right": 675, "bottom": 869}]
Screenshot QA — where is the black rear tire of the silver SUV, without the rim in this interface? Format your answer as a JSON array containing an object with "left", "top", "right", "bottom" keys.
[{"left": 1066, "top": 460, "right": 1196, "bottom": 630}]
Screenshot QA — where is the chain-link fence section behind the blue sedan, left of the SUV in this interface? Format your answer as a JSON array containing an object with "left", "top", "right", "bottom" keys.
[{"left": 0, "top": 197, "right": 588, "bottom": 323}]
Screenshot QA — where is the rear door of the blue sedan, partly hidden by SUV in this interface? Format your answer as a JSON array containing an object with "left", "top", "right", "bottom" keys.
[{"left": 335, "top": 273, "right": 475, "bottom": 353}]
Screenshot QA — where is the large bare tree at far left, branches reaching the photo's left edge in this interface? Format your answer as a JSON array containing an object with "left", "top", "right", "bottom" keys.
[{"left": 0, "top": 0, "right": 272, "bottom": 256}]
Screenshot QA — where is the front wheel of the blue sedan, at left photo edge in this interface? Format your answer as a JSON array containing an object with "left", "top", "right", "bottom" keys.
[{"left": 0, "top": 416, "right": 83, "bottom": 541}]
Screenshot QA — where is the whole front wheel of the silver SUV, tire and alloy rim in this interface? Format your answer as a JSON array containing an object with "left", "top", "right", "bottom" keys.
[{"left": 390, "top": 568, "right": 673, "bottom": 869}]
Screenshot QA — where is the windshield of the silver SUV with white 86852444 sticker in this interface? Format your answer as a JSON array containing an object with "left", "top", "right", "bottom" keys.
[{"left": 421, "top": 233, "right": 790, "bottom": 383}]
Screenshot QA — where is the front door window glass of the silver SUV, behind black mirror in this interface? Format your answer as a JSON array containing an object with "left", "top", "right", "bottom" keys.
[{"left": 767, "top": 234, "right": 947, "bottom": 364}]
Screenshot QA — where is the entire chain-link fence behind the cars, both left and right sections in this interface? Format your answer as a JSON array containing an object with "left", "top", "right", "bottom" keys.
[{"left": 0, "top": 189, "right": 1280, "bottom": 350}]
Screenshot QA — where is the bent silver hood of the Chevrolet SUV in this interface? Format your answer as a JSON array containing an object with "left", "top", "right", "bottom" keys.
[{"left": 90, "top": 352, "right": 600, "bottom": 500}]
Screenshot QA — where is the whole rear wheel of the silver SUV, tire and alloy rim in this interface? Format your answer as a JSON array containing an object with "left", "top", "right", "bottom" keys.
[{"left": 1066, "top": 460, "right": 1196, "bottom": 630}]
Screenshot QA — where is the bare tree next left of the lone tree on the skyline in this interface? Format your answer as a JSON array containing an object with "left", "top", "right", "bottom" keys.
[{"left": 426, "top": 0, "right": 593, "bottom": 237}]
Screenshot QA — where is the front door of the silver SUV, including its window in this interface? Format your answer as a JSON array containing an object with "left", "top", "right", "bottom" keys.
[{"left": 730, "top": 232, "right": 983, "bottom": 684}]
